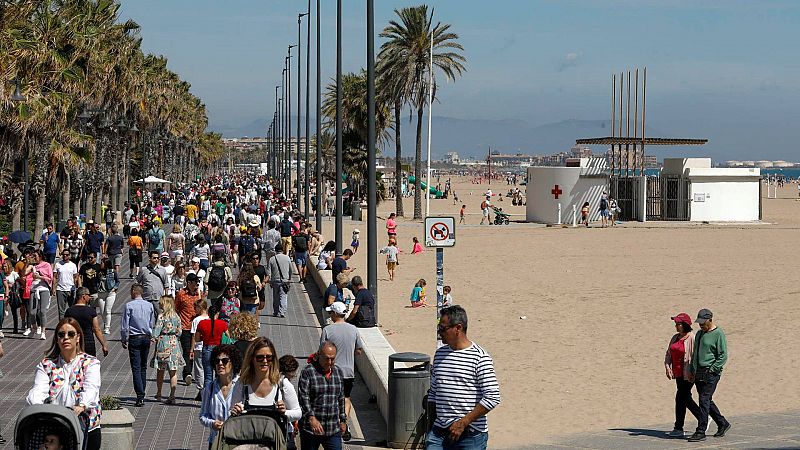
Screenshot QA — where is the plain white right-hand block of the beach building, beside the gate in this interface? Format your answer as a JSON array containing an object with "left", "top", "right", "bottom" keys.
[{"left": 689, "top": 176, "right": 759, "bottom": 222}]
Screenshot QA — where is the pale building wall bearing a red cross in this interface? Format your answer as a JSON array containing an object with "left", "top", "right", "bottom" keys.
[{"left": 526, "top": 167, "right": 608, "bottom": 224}]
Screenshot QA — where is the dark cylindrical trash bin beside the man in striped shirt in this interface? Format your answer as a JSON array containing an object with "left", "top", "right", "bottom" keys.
[{"left": 386, "top": 352, "right": 431, "bottom": 448}]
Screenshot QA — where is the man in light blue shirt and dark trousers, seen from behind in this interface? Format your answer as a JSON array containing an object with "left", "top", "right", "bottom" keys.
[{"left": 120, "top": 284, "right": 156, "bottom": 407}]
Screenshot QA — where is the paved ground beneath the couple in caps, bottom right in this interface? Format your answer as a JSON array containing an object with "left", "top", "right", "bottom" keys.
[{"left": 526, "top": 411, "right": 800, "bottom": 450}]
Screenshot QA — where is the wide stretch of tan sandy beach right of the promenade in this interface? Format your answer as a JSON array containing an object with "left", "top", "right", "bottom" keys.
[{"left": 323, "top": 177, "right": 800, "bottom": 448}]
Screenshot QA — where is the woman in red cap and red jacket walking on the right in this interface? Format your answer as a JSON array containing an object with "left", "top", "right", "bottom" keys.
[{"left": 664, "top": 313, "right": 700, "bottom": 438}]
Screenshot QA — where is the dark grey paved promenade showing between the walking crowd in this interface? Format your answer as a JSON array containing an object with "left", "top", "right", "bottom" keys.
[{"left": 0, "top": 248, "right": 383, "bottom": 450}]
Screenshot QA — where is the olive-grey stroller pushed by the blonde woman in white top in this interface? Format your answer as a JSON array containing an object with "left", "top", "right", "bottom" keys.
[{"left": 211, "top": 386, "right": 287, "bottom": 450}]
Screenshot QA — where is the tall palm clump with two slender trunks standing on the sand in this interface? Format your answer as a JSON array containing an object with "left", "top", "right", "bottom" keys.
[{"left": 379, "top": 5, "right": 466, "bottom": 219}]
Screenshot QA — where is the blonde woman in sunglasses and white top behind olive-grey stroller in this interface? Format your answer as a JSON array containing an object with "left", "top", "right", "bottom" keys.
[{"left": 231, "top": 336, "right": 303, "bottom": 422}]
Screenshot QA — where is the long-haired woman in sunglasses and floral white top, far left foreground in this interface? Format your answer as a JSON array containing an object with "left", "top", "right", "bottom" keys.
[{"left": 26, "top": 317, "right": 101, "bottom": 450}]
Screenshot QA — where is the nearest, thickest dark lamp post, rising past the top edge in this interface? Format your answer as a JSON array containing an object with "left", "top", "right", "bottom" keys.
[{"left": 367, "top": 0, "right": 378, "bottom": 310}]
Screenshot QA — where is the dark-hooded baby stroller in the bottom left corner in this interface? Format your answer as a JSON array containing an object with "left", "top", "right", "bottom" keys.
[{"left": 14, "top": 404, "right": 88, "bottom": 450}]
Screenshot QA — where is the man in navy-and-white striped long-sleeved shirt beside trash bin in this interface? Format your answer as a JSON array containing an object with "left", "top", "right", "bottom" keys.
[{"left": 427, "top": 305, "right": 500, "bottom": 450}]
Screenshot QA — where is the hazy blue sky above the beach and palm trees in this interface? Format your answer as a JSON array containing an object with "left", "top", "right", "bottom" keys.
[{"left": 122, "top": 0, "right": 800, "bottom": 160}]
